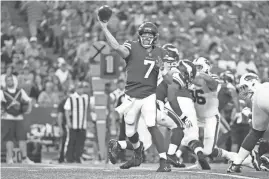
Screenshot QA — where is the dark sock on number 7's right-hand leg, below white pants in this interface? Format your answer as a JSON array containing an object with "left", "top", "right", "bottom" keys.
[{"left": 148, "top": 126, "right": 166, "bottom": 155}]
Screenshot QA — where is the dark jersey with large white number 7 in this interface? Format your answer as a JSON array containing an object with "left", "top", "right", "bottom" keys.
[{"left": 123, "top": 41, "right": 167, "bottom": 99}]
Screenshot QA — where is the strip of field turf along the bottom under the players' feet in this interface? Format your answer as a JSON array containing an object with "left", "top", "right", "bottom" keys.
[{"left": 1, "top": 164, "right": 269, "bottom": 179}]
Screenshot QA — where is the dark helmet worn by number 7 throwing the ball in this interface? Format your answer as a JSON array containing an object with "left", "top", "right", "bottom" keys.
[{"left": 138, "top": 22, "right": 159, "bottom": 48}]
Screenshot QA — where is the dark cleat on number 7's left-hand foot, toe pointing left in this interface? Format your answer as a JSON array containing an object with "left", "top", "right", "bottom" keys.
[{"left": 120, "top": 142, "right": 144, "bottom": 169}]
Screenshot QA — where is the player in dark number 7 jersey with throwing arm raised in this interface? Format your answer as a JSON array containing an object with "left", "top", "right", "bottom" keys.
[{"left": 97, "top": 16, "right": 171, "bottom": 172}]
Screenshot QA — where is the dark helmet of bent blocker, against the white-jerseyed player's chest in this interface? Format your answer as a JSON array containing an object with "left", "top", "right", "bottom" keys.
[{"left": 178, "top": 60, "right": 197, "bottom": 85}]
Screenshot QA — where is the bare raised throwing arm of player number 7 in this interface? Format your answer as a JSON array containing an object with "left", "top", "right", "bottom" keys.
[{"left": 97, "top": 15, "right": 131, "bottom": 59}]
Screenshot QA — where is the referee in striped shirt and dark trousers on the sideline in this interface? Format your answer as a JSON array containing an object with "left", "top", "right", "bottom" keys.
[{"left": 64, "top": 82, "right": 90, "bottom": 163}]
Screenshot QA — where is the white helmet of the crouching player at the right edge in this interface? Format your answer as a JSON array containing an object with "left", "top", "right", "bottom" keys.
[{"left": 238, "top": 73, "right": 260, "bottom": 99}]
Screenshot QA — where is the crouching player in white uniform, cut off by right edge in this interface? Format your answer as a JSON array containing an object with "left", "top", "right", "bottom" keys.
[{"left": 227, "top": 73, "right": 269, "bottom": 173}]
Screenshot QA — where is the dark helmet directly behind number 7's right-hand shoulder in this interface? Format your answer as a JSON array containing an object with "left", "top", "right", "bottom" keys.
[{"left": 162, "top": 44, "right": 179, "bottom": 67}]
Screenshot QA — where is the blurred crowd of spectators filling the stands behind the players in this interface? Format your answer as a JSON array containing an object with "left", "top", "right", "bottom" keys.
[{"left": 1, "top": 0, "right": 269, "bottom": 164}]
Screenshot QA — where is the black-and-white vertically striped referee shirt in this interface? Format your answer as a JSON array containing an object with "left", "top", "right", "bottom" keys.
[{"left": 64, "top": 92, "right": 89, "bottom": 129}]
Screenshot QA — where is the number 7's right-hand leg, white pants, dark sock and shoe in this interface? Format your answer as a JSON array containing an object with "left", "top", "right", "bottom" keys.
[{"left": 141, "top": 94, "right": 171, "bottom": 172}]
